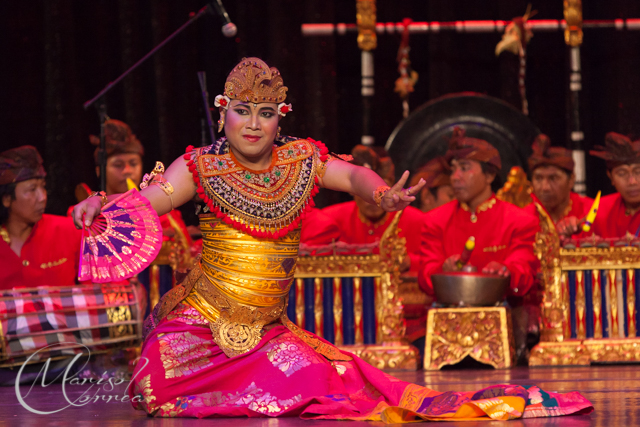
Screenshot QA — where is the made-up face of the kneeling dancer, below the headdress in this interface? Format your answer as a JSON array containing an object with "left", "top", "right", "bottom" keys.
[{"left": 224, "top": 100, "right": 280, "bottom": 162}]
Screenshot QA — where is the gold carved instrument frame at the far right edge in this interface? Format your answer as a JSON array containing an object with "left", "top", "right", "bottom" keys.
[{"left": 529, "top": 205, "right": 640, "bottom": 366}]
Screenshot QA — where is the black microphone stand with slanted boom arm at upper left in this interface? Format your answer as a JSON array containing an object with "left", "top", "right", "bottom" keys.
[{"left": 82, "top": 4, "right": 215, "bottom": 191}]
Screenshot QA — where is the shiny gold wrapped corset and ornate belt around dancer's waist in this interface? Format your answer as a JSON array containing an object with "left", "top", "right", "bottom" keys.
[{"left": 184, "top": 216, "right": 300, "bottom": 357}]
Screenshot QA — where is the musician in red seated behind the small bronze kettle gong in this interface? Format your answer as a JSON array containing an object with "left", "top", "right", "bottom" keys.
[{"left": 419, "top": 128, "right": 538, "bottom": 296}]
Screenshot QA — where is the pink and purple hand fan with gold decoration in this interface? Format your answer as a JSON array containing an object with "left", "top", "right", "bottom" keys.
[{"left": 78, "top": 188, "right": 162, "bottom": 283}]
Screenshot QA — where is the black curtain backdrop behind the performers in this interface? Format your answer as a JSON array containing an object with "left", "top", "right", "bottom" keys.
[{"left": 0, "top": 0, "right": 640, "bottom": 224}]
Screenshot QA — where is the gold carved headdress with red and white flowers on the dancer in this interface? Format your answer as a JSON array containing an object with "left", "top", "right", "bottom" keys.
[{"left": 214, "top": 58, "right": 293, "bottom": 132}]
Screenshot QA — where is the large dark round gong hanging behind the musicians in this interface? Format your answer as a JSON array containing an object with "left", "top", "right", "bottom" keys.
[{"left": 385, "top": 92, "right": 540, "bottom": 182}]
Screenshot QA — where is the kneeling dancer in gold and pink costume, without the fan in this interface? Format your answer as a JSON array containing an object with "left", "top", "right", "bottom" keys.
[{"left": 74, "top": 58, "right": 591, "bottom": 422}]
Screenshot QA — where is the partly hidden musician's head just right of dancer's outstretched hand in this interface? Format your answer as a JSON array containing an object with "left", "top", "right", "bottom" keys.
[{"left": 411, "top": 157, "right": 454, "bottom": 212}]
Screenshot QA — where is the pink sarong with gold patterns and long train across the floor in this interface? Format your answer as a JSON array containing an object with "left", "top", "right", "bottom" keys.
[{"left": 130, "top": 304, "right": 593, "bottom": 423}]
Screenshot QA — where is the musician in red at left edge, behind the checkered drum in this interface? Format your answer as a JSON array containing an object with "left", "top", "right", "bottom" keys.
[{"left": 0, "top": 145, "right": 82, "bottom": 289}]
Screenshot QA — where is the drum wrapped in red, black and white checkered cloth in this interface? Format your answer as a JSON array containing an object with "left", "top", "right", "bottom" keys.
[{"left": 0, "top": 281, "right": 145, "bottom": 368}]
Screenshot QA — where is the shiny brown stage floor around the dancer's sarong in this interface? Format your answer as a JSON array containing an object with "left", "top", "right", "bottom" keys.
[{"left": 0, "top": 365, "right": 640, "bottom": 427}]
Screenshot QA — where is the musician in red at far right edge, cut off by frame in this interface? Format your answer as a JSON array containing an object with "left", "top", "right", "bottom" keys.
[{"left": 558, "top": 132, "right": 640, "bottom": 238}]
